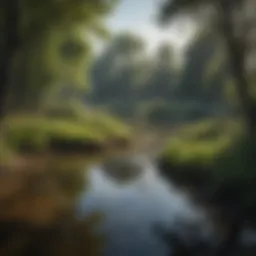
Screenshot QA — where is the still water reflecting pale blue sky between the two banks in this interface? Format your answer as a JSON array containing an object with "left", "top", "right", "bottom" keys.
[{"left": 78, "top": 158, "right": 213, "bottom": 256}]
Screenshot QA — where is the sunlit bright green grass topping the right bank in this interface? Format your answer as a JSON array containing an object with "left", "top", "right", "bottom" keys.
[{"left": 163, "top": 120, "right": 241, "bottom": 165}]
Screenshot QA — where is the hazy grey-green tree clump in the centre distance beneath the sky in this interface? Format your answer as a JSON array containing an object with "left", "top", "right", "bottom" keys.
[{"left": 92, "top": 32, "right": 181, "bottom": 120}]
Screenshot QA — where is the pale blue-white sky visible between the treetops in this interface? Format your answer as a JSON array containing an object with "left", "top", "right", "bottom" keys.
[{"left": 104, "top": 0, "right": 194, "bottom": 52}]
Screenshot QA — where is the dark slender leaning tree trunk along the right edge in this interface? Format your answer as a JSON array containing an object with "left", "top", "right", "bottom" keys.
[{"left": 218, "top": 0, "right": 256, "bottom": 135}]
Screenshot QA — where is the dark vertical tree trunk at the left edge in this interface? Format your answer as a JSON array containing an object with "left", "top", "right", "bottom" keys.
[{"left": 0, "top": 0, "right": 19, "bottom": 121}]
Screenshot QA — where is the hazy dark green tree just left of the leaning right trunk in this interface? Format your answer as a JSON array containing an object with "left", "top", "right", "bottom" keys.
[{"left": 177, "top": 26, "right": 231, "bottom": 111}]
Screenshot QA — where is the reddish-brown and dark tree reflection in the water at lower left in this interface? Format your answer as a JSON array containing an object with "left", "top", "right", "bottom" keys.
[{"left": 0, "top": 162, "right": 104, "bottom": 256}]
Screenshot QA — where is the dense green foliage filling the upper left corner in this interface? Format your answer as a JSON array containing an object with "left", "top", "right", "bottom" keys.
[{"left": 0, "top": 0, "right": 114, "bottom": 112}]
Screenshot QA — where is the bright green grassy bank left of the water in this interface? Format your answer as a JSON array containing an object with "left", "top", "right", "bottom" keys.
[{"left": 2, "top": 113, "right": 131, "bottom": 156}]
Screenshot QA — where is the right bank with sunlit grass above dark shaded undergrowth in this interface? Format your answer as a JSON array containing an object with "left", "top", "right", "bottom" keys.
[{"left": 159, "top": 117, "right": 256, "bottom": 225}]
